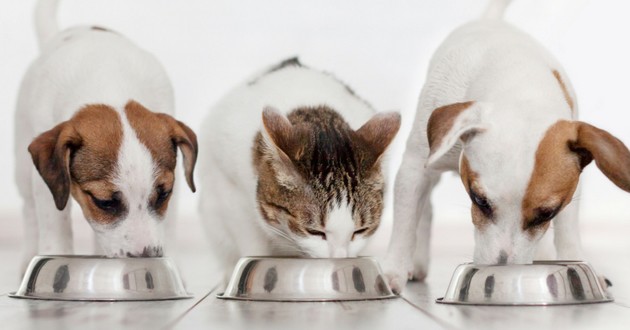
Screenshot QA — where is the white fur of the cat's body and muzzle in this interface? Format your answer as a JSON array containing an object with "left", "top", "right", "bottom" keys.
[{"left": 200, "top": 62, "right": 375, "bottom": 278}]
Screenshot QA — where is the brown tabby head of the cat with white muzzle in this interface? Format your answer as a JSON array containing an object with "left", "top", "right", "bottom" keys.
[{"left": 253, "top": 106, "right": 400, "bottom": 257}]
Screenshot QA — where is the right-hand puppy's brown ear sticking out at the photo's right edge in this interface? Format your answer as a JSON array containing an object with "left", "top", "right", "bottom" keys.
[{"left": 569, "top": 122, "right": 630, "bottom": 192}]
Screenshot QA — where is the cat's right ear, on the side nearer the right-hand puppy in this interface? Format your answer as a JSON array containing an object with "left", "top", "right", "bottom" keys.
[{"left": 356, "top": 112, "right": 400, "bottom": 164}]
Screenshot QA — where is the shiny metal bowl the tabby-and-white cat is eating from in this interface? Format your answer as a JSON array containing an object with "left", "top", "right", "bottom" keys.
[{"left": 217, "top": 257, "right": 395, "bottom": 301}]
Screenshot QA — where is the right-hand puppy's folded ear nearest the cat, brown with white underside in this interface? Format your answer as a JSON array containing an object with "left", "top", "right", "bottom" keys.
[{"left": 426, "top": 102, "right": 483, "bottom": 167}]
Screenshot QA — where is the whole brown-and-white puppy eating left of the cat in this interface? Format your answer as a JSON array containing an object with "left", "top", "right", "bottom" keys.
[{"left": 16, "top": 0, "right": 197, "bottom": 268}]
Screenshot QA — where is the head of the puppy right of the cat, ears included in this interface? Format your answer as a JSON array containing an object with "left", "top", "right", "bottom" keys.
[{"left": 427, "top": 102, "right": 630, "bottom": 264}]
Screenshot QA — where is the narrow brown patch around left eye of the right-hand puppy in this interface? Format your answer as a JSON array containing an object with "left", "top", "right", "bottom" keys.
[{"left": 459, "top": 156, "right": 495, "bottom": 230}]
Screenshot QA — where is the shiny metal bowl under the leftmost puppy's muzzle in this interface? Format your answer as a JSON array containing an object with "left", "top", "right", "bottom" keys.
[{"left": 10, "top": 256, "right": 191, "bottom": 301}]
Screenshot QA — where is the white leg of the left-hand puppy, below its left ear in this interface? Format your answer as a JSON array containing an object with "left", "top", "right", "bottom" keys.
[{"left": 31, "top": 168, "right": 73, "bottom": 254}]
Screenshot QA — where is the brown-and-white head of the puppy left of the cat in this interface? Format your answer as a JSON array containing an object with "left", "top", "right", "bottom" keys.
[{"left": 28, "top": 101, "right": 197, "bottom": 257}]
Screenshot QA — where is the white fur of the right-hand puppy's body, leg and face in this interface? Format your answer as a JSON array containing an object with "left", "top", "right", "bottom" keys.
[{"left": 383, "top": 0, "right": 580, "bottom": 291}]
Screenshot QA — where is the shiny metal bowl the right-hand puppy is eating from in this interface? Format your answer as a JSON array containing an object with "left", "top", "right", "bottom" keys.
[{"left": 437, "top": 261, "right": 613, "bottom": 305}]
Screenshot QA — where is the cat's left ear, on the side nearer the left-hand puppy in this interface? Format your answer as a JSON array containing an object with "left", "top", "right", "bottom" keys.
[{"left": 262, "top": 107, "right": 301, "bottom": 189}]
